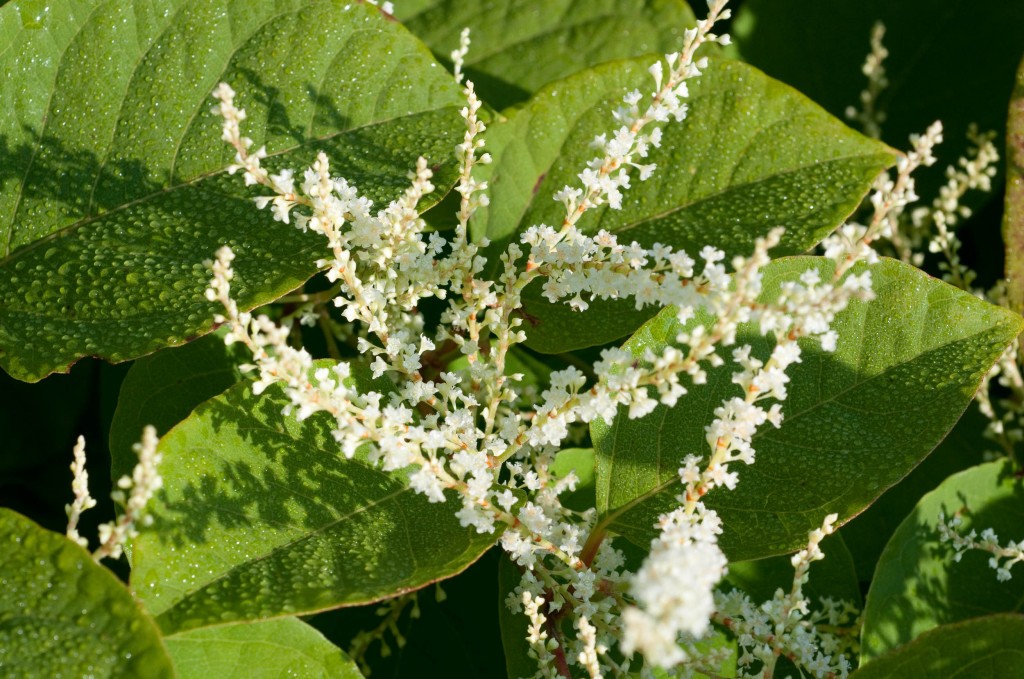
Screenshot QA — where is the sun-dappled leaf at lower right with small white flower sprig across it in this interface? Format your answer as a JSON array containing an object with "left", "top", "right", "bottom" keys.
[{"left": 861, "top": 461, "right": 1024, "bottom": 660}]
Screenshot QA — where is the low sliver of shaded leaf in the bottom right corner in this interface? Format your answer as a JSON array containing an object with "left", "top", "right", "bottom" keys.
[{"left": 850, "top": 614, "right": 1024, "bottom": 679}]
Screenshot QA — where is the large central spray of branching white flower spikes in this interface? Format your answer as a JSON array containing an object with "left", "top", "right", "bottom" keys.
[{"left": 199, "top": 0, "right": 905, "bottom": 676}]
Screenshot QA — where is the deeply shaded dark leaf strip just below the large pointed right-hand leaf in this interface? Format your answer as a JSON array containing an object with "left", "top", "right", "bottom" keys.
[{"left": 842, "top": 404, "right": 994, "bottom": 583}]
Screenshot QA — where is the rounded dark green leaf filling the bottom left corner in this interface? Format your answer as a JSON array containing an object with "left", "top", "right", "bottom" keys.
[{"left": 0, "top": 508, "right": 174, "bottom": 678}]
